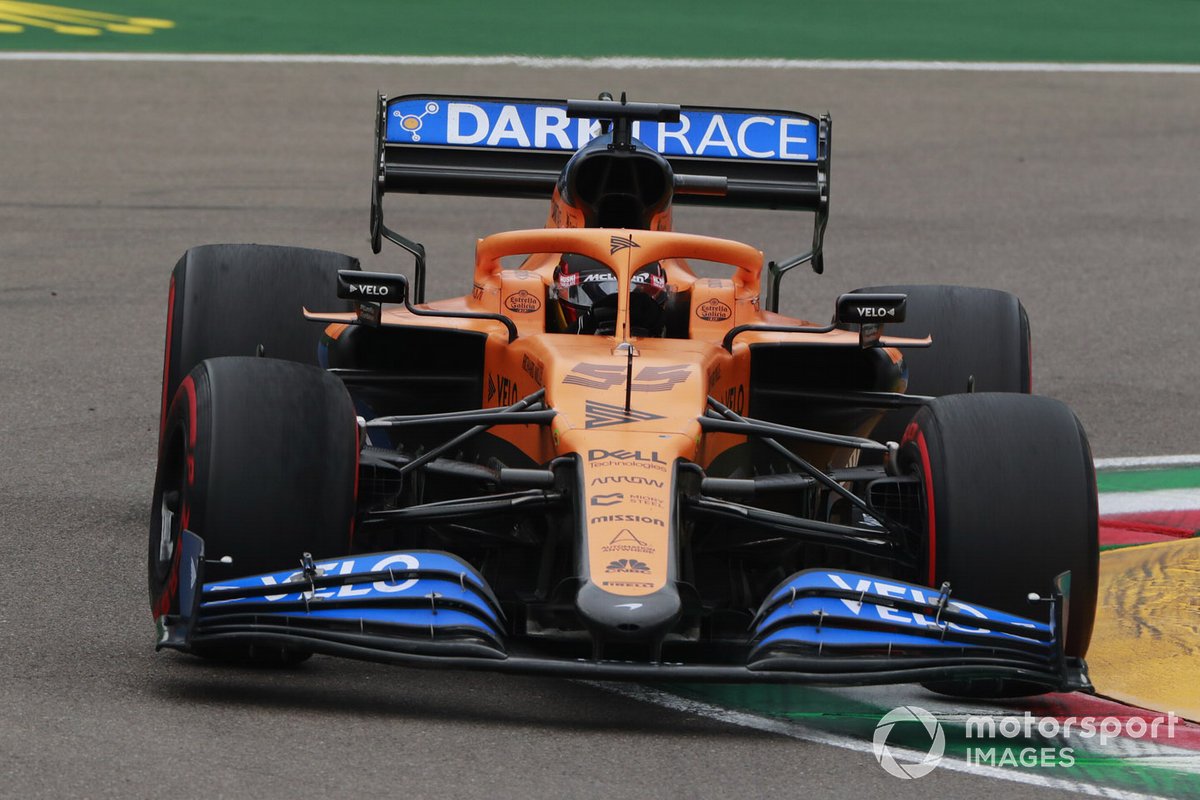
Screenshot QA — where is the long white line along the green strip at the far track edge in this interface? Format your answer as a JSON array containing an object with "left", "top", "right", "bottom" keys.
[{"left": 0, "top": 50, "right": 1200, "bottom": 74}]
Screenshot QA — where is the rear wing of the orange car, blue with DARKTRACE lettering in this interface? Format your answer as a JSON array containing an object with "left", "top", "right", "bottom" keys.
[{"left": 371, "top": 95, "right": 832, "bottom": 302}]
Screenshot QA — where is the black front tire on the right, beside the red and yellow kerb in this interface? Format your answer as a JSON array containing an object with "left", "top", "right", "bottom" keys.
[{"left": 900, "top": 392, "right": 1099, "bottom": 697}]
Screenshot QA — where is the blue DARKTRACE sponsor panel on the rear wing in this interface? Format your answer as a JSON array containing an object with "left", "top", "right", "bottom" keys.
[{"left": 386, "top": 96, "right": 817, "bottom": 161}]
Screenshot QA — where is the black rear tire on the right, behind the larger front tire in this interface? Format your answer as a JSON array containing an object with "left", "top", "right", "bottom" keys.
[{"left": 854, "top": 285, "right": 1032, "bottom": 450}]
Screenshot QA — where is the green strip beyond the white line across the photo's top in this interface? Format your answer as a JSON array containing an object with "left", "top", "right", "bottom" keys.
[{"left": 0, "top": 0, "right": 1200, "bottom": 64}]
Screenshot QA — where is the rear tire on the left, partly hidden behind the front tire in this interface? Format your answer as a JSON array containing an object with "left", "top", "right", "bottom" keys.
[{"left": 160, "top": 245, "right": 360, "bottom": 448}]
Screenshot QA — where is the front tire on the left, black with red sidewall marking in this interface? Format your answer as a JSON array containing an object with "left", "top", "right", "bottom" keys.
[{"left": 149, "top": 357, "right": 359, "bottom": 664}]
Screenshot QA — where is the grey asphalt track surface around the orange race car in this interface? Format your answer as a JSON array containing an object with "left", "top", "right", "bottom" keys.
[{"left": 0, "top": 62, "right": 1200, "bottom": 799}]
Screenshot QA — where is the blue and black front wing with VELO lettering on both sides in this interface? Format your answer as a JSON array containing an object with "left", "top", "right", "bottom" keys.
[{"left": 157, "top": 531, "right": 1091, "bottom": 691}]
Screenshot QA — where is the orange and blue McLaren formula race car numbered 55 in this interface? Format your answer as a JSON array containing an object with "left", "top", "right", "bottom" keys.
[{"left": 149, "top": 95, "right": 1098, "bottom": 696}]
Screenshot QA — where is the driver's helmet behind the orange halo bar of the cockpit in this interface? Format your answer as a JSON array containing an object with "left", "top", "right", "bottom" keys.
[{"left": 554, "top": 253, "right": 668, "bottom": 336}]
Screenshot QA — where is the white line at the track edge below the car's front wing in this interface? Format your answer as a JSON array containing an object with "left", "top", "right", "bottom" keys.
[{"left": 583, "top": 681, "right": 1158, "bottom": 800}]
